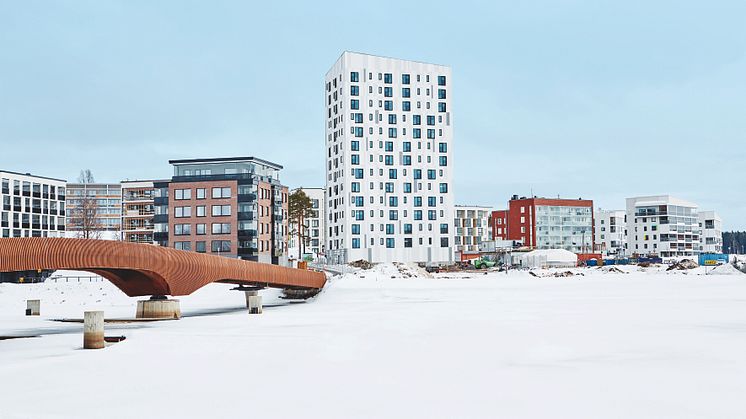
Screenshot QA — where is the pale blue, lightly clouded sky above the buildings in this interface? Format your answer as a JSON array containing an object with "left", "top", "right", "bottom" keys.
[{"left": 0, "top": 0, "right": 746, "bottom": 230}]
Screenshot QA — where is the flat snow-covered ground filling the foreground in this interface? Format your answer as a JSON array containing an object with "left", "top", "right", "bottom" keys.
[{"left": 0, "top": 265, "right": 746, "bottom": 419}]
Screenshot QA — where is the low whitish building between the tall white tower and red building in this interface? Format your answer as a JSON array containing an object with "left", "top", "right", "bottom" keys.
[{"left": 453, "top": 205, "right": 492, "bottom": 255}]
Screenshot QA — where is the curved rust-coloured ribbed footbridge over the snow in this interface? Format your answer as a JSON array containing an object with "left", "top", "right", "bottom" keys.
[{"left": 0, "top": 237, "right": 326, "bottom": 297}]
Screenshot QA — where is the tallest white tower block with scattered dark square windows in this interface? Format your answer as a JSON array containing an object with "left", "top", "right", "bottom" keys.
[{"left": 324, "top": 52, "right": 453, "bottom": 263}]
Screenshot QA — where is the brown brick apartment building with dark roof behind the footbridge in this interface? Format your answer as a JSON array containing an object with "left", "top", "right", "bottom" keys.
[{"left": 153, "top": 157, "right": 288, "bottom": 265}]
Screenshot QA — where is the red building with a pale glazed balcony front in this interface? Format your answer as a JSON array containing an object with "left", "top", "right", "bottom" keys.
[{"left": 507, "top": 195, "right": 595, "bottom": 253}]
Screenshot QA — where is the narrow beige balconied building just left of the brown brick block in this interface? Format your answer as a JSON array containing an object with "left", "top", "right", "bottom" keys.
[{"left": 121, "top": 180, "right": 162, "bottom": 244}]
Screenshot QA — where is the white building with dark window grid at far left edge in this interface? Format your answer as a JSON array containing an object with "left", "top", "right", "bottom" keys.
[{"left": 0, "top": 171, "right": 66, "bottom": 237}]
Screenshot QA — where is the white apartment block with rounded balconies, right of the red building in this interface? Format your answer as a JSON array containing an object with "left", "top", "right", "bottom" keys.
[{"left": 627, "top": 195, "right": 700, "bottom": 258}]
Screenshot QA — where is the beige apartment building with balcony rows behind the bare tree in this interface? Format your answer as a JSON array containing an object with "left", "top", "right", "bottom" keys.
[{"left": 67, "top": 183, "right": 122, "bottom": 240}]
